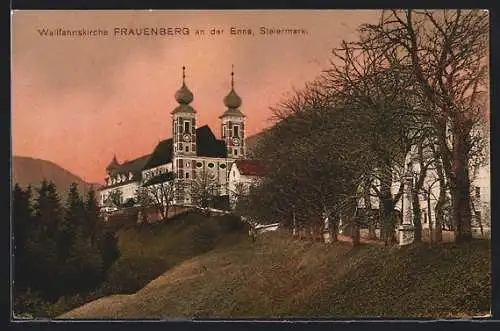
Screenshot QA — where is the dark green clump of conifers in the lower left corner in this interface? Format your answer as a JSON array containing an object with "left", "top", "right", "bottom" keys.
[{"left": 12, "top": 181, "right": 119, "bottom": 315}]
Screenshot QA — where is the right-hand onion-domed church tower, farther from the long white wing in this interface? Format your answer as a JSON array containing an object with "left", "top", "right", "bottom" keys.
[{"left": 219, "top": 66, "right": 246, "bottom": 159}]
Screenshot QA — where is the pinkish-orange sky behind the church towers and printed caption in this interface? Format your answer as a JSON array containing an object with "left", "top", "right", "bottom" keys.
[{"left": 12, "top": 10, "right": 380, "bottom": 183}]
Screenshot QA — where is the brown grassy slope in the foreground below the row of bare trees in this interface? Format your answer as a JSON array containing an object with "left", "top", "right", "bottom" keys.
[{"left": 62, "top": 224, "right": 491, "bottom": 318}]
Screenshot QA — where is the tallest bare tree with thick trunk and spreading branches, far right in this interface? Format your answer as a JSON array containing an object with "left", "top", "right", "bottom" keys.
[{"left": 362, "top": 10, "right": 488, "bottom": 241}]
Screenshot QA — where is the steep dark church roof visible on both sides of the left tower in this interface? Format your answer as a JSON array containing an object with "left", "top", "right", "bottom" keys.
[{"left": 143, "top": 125, "right": 227, "bottom": 170}]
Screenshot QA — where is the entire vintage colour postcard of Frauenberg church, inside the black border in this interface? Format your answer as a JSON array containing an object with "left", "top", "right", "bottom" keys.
[{"left": 11, "top": 9, "right": 491, "bottom": 320}]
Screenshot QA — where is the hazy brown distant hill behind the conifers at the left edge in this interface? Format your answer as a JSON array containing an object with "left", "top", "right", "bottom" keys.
[{"left": 12, "top": 156, "right": 99, "bottom": 199}]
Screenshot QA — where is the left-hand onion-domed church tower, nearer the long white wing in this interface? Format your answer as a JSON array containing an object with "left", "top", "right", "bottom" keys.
[{"left": 172, "top": 67, "right": 196, "bottom": 158}]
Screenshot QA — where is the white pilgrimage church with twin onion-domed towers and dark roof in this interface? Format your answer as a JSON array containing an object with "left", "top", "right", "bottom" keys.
[{"left": 100, "top": 67, "right": 250, "bottom": 207}]
